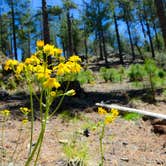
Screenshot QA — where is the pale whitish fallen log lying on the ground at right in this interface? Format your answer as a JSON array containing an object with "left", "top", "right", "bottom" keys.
[{"left": 96, "top": 103, "right": 166, "bottom": 120}]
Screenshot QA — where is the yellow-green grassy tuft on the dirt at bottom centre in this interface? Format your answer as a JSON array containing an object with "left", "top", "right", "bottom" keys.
[{"left": 63, "top": 132, "right": 88, "bottom": 166}]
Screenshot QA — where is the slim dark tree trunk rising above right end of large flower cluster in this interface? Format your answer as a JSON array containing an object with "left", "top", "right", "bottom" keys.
[{"left": 66, "top": 9, "right": 73, "bottom": 57}]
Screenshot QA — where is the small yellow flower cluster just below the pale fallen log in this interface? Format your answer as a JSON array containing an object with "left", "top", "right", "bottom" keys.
[{"left": 98, "top": 107, "right": 119, "bottom": 124}]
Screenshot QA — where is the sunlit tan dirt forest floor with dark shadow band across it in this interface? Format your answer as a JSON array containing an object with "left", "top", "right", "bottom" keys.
[{"left": 0, "top": 82, "right": 166, "bottom": 166}]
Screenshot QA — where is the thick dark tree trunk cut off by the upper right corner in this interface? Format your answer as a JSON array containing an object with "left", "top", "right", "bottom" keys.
[{"left": 155, "top": 0, "right": 166, "bottom": 48}]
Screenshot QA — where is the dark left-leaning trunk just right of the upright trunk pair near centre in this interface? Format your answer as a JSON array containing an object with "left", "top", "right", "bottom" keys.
[{"left": 114, "top": 12, "right": 124, "bottom": 65}]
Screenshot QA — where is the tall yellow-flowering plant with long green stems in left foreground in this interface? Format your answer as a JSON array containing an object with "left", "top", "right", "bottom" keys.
[{"left": 4, "top": 40, "right": 82, "bottom": 166}]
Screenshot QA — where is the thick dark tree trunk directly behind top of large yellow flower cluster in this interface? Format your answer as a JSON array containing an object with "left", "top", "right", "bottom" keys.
[{"left": 42, "top": 0, "right": 51, "bottom": 64}]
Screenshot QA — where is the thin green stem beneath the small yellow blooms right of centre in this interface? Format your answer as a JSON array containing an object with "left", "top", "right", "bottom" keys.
[{"left": 99, "top": 123, "right": 105, "bottom": 166}]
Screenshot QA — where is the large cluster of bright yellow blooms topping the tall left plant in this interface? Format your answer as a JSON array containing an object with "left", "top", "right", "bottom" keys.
[{"left": 4, "top": 40, "right": 82, "bottom": 89}]
